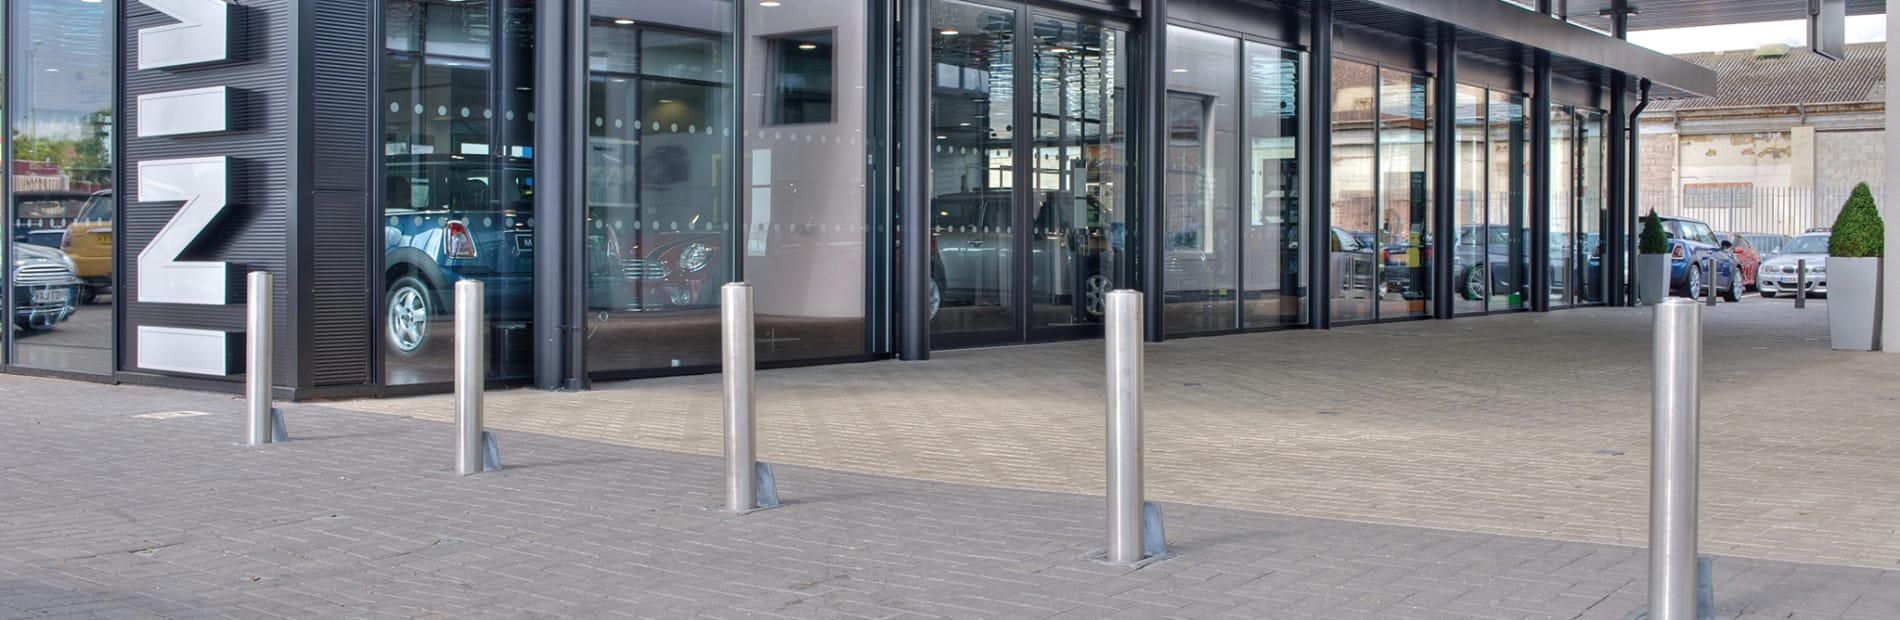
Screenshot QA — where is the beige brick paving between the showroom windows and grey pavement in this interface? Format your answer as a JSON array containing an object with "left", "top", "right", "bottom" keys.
[{"left": 336, "top": 297, "right": 1900, "bottom": 569}]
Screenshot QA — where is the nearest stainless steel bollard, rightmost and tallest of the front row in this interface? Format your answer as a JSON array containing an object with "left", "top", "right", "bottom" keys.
[{"left": 1649, "top": 299, "right": 1702, "bottom": 620}]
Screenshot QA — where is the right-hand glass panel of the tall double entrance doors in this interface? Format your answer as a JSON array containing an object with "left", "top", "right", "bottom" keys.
[{"left": 1030, "top": 15, "right": 1129, "bottom": 327}]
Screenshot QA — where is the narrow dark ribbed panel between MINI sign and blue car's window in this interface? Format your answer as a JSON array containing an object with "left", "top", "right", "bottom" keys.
[{"left": 300, "top": 0, "right": 380, "bottom": 386}]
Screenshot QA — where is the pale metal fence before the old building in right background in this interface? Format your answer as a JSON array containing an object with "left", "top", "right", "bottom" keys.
[{"left": 1636, "top": 184, "right": 1881, "bottom": 236}]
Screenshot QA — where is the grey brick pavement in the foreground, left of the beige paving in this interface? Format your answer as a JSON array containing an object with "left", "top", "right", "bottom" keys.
[{"left": 0, "top": 377, "right": 1900, "bottom": 618}]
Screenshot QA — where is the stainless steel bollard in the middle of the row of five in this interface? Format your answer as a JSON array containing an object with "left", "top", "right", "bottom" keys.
[{"left": 720, "top": 281, "right": 758, "bottom": 512}]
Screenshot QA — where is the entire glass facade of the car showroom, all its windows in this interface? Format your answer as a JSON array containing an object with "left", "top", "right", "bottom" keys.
[{"left": 0, "top": 0, "right": 1664, "bottom": 386}]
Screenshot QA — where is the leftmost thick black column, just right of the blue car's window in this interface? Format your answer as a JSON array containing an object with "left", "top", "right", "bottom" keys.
[{"left": 532, "top": 0, "right": 566, "bottom": 390}]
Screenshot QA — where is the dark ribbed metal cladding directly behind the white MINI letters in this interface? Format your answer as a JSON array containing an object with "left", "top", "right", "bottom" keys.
[{"left": 114, "top": 0, "right": 290, "bottom": 382}]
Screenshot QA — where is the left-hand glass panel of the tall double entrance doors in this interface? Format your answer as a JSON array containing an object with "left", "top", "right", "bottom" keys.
[{"left": 931, "top": 0, "right": 1017, "bottom": 333}]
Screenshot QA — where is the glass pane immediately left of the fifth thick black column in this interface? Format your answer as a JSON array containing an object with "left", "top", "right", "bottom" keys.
[{"left": 1378, "top": 72, "right": 1433, "bottom": 320}]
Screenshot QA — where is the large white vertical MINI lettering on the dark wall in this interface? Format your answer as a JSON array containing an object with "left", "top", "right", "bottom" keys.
[{"left": 131, "top": 0, "right": 243, "bottom": 377}]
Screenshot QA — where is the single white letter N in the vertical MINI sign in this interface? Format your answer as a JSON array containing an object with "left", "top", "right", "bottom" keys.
[{"left": 133, "top": 158, "right": 230, "bottom": 304}]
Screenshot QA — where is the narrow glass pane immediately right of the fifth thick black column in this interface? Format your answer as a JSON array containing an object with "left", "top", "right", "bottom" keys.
[{"left": 1452, "top": 86, "right": 1482, "bottom": 314}]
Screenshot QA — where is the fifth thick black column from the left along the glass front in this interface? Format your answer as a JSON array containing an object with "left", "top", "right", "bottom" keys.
[{"left": 1425, "top": 25, "right": 1457, "bottom": 320}]
